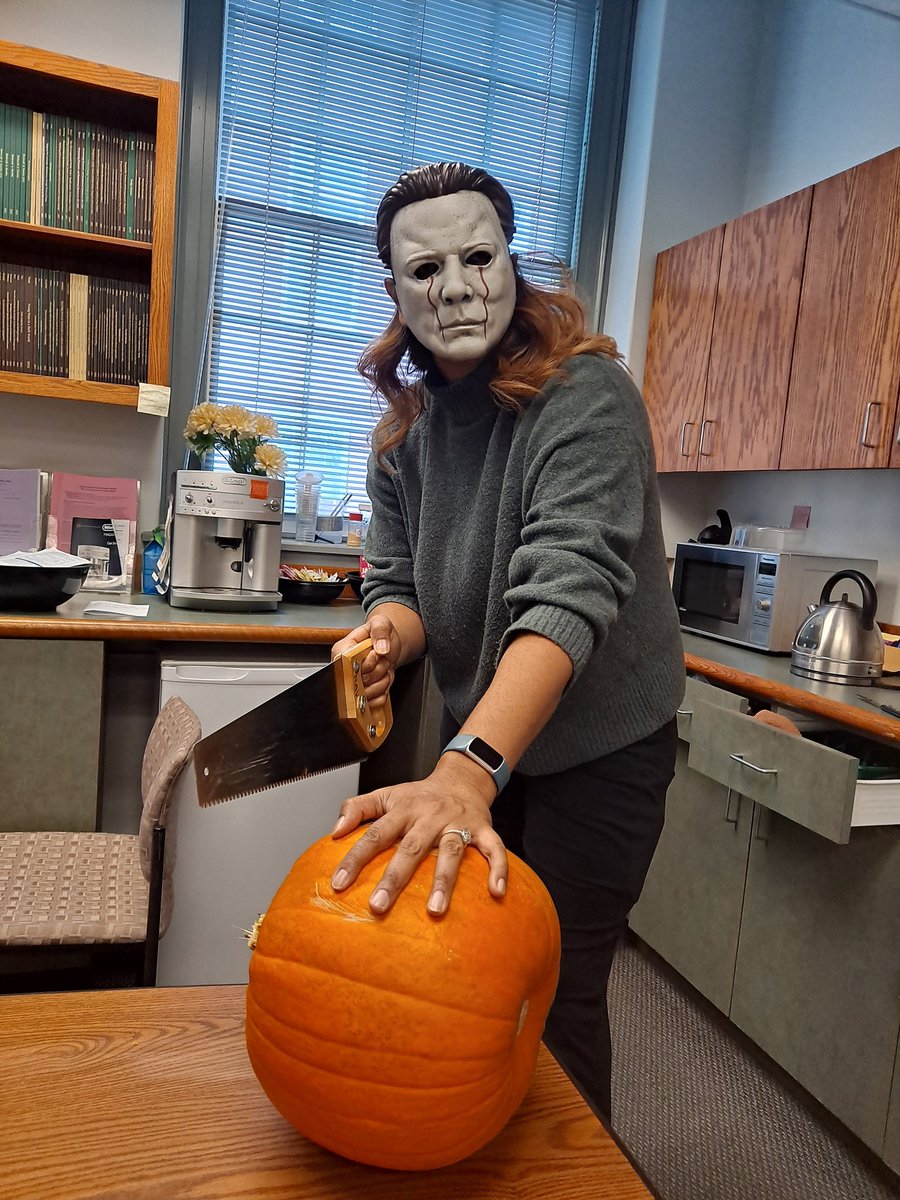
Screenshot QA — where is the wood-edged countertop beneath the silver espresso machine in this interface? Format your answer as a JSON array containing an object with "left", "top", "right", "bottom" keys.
[{"left": 0, "top": 592, "right": 365, "bottom": 646}]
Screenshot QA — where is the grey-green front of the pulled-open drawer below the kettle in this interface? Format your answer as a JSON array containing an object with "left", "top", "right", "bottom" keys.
[{"left": 688, "top": 704, "right": 859, "bottom": 842}]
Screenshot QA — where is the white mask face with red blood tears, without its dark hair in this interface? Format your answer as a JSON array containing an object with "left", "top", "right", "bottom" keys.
[{"left": 385, "top": 192, "right": 516, "bottom": 380}]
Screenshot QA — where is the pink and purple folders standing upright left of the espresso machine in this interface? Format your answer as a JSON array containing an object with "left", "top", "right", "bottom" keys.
[{"left": 0, "top": 467, "right": 140, "bottom": 592}]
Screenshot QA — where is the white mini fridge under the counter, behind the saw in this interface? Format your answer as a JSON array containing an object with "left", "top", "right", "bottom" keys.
[{"left": 157, "top": 659, "right": 359, "bottom": 985}]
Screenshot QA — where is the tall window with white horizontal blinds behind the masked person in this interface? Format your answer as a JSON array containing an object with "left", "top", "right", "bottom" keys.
[{"left": 209, "top": 0, "right": 599, "bottom": 511}]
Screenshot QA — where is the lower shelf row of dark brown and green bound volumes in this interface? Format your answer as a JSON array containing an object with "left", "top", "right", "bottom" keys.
[{"left": 0, "top": 263, "right": 150, "bottom": 384}]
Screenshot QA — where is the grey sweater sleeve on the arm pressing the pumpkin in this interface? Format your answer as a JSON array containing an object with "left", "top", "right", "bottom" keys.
[{"left": 498, "top": 355, "right": 653, "bottom": 679}]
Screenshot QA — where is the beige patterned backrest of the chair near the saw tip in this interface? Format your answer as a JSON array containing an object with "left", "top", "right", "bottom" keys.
[{"left": 139, "top": 696, "right": 200, "bottom": 934}]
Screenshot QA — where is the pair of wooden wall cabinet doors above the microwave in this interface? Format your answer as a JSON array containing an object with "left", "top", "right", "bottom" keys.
[{"left": 644, "top": 188, "right": 812, "bottom": 470}]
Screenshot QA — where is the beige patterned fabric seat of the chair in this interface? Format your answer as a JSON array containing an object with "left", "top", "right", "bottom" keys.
[{"left": 0, "top": 832, "right": 148, "bottom": 946}]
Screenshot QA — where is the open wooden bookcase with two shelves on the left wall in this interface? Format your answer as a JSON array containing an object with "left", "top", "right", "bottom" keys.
[{"left": 0, "top": 41, "right": 179, "bottom": 407}]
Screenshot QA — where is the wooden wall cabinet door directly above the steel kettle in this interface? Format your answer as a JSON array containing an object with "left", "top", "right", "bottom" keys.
[{"left": 780, "top": 149, "right": 900, "bottom": 470}]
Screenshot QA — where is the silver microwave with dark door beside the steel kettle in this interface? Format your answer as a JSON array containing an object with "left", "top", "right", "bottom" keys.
[{"left": 672, "top": 541, "right": 878, "bottom": 654}]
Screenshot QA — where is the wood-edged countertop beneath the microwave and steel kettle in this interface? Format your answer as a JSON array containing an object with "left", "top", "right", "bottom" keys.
[{"left": 682, "top": 632, "right": 900, "bottom": 744}]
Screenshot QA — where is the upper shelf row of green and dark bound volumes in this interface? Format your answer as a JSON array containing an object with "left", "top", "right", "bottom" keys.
[{"left": 0, "top": 104, "right": 155, "bottom": 241}]
